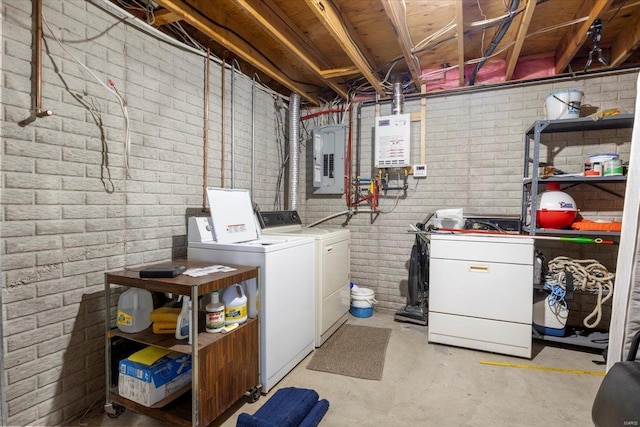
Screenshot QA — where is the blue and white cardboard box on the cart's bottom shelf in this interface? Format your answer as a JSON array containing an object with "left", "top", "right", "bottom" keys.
[{"left": 118, "top": 352, "right": 191, "bottom": 406}]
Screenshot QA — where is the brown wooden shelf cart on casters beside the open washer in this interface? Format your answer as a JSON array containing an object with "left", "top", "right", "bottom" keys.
[{"left": 105, "top": 260, "right": 262, "bottom": 426}]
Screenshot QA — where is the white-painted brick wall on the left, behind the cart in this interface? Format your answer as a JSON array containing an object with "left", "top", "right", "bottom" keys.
[{"left": 0, "top": 0, "right": 279, "bottom": 425}]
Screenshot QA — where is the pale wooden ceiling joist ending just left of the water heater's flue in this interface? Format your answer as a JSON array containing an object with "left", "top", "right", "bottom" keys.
[{"left": 305, "top": 0, "right": 387, "bottom": 97}]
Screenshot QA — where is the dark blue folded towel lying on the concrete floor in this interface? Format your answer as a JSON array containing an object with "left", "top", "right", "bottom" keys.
[{"left": 236, "top": 387, "right": 329, "bottom": 427}]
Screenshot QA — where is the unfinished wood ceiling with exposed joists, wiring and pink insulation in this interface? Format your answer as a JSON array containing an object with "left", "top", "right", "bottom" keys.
[{"left": 111, "top": 0, "right": 640, "bottom": 104}]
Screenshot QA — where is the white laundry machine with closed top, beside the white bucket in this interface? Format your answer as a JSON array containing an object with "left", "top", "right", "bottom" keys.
[{"left": 258, "top": 211, "right": 351, "bottom": 347}]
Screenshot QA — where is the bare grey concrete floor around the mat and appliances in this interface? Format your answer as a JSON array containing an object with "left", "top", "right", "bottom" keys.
[{"left": 74, "top": 310, "right": 605, "bottom": 427}]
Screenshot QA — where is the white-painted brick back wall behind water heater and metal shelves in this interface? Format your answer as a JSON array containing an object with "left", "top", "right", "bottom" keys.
[{"left": 301, "top": 72, "right": 637, "bottom": 309}]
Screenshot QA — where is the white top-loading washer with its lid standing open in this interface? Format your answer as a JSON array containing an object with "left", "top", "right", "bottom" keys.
[{"left": 187, "top": 188, "right": 315, "bottom": 393}]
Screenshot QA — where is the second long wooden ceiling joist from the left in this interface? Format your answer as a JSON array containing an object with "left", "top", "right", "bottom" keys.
[{"left": 232, "top": 0, "right": 348, "bottom": 99}]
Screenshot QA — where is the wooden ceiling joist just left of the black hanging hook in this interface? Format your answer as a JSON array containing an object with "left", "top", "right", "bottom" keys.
[{"left": 556, "top": 0, "right": 613, "bottom": 74}]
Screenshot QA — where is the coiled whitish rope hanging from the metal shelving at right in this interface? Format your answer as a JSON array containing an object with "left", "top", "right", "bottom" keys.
[{"left": 548, "top": 256, "right": 615, "bottom": 328}]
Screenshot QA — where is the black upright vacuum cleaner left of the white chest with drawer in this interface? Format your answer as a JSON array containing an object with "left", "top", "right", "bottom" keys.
[{"left": 394, "top": 219, "right": 431, "bottom": 326}]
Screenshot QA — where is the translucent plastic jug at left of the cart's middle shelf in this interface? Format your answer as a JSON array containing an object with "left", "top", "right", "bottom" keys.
[{"left": 116, "top": 288, "right": 153, "bottom": 333}]
